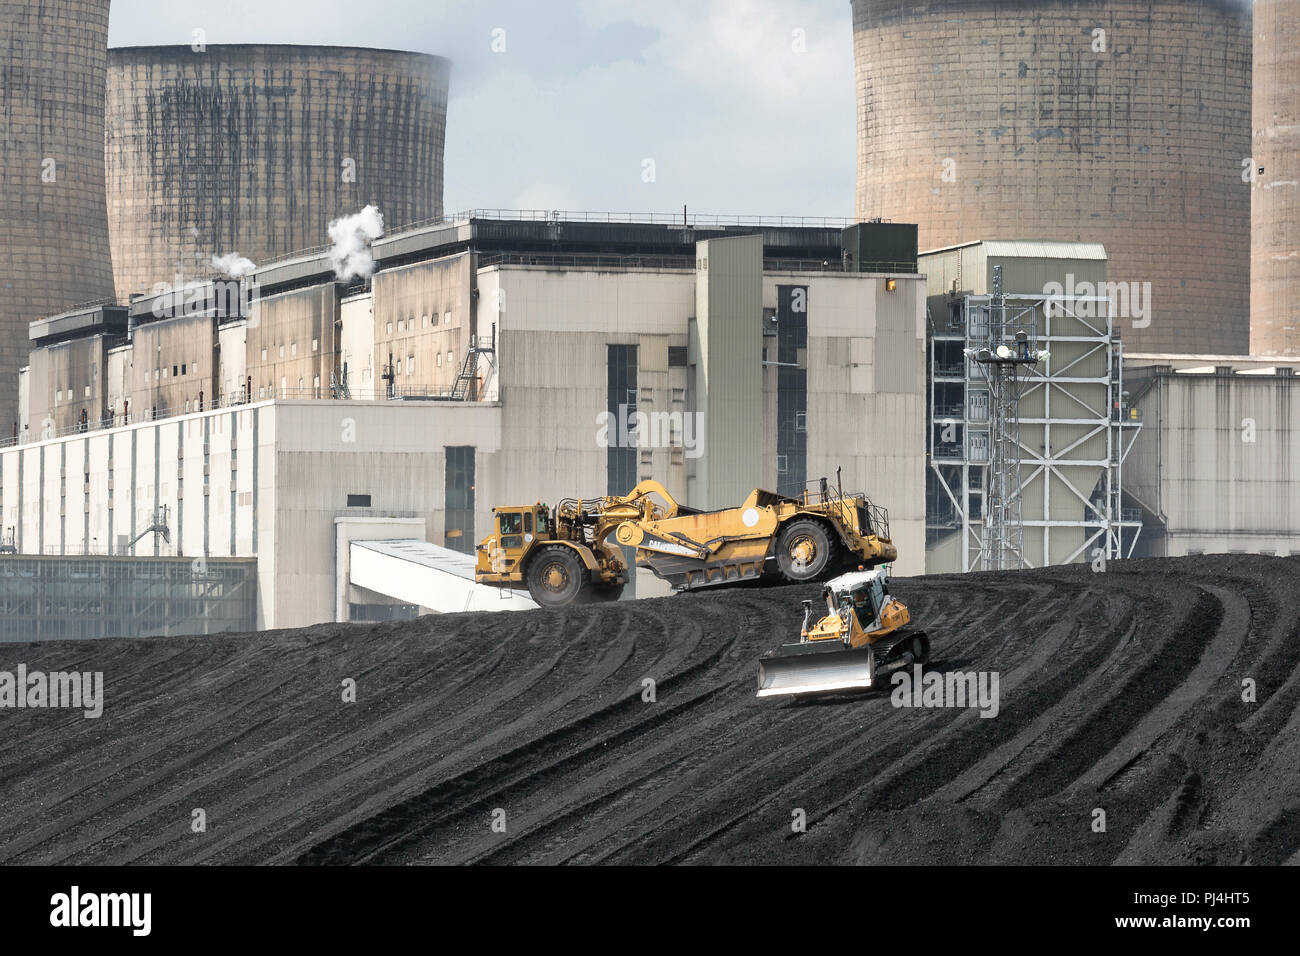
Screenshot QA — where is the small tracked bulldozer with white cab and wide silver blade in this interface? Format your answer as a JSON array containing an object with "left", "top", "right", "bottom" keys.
[{"left": 758, "top": 567, "right": 930, "bottom": 697}]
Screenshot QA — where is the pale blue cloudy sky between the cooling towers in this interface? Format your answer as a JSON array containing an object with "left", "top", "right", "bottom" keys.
[{"left": 109, "top": 0, "right": 855, "bottom": 216}]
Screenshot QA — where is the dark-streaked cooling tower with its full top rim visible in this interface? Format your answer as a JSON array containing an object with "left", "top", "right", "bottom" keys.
[{"left": 105, "top": 44, "right": 450, "bottom": 299}]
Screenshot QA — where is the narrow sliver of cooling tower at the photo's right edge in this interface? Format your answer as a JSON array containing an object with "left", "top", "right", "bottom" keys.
[{"left": 1251, "top": 0, "right": 1300, "bottom": 355}]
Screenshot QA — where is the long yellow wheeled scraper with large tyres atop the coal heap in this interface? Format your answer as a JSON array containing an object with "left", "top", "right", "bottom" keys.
[{"left": 475, "top": 479, "right": 898, "bottom": 607}]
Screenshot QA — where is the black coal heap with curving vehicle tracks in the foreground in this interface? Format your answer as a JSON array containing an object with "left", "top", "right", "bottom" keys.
[{"left": 0, "top": 555, "right": 1300, "bottom": 864}]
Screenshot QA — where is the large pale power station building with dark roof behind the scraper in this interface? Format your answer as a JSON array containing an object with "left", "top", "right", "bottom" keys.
[{"left": 0, "top": 215, "right": 926, "bottom": 630}]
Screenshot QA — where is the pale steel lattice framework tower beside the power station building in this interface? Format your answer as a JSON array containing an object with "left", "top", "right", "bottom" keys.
[{"left": 927, "top": 282, "right": 1141, "bottom": 571}]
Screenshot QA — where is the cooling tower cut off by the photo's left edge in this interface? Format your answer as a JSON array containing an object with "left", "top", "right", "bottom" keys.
[{"left": 0, "top": 0, "right": 113, "bottom": 437}]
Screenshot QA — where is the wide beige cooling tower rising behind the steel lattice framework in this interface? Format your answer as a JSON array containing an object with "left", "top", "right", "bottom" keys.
[{"left": 853, "top": 0, "right": 1251, "bottom": 354}]
